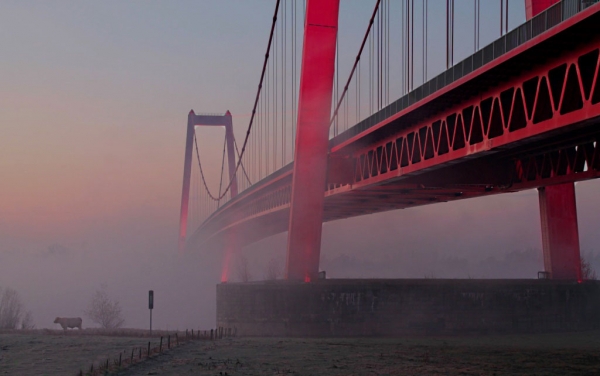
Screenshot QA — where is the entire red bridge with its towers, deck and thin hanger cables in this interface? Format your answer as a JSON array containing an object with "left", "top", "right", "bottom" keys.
[{"left": 180, "top": 0, "right": 600, "bottom": 281}]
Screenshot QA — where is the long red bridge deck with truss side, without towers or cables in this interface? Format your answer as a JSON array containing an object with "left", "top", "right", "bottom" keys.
[{"left": 189, "top": 0, "right": 600, "bottom": 280}]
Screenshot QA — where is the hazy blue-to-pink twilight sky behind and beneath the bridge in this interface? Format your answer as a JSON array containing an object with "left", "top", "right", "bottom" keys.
[{"left": 0, "top": 0, "right": 600, "bottom": 329}]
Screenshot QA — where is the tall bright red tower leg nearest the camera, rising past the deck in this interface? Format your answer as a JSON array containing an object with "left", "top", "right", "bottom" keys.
[{"left": 286, "top": 0, "right": 340, "bottom": 282}]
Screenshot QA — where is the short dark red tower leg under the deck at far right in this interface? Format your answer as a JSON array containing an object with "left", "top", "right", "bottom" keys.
[{"left": 538, "top": 183, "right": 581, "bottom": 281}]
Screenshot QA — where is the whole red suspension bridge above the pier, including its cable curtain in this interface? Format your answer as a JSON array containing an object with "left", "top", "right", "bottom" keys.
[{"left": 179, "top": 0, "right": 600, "bottom": 281}]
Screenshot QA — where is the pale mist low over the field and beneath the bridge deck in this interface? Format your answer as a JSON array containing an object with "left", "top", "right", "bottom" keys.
[{"left": 0, "top": 178, "right": 600, "bottom": 329}]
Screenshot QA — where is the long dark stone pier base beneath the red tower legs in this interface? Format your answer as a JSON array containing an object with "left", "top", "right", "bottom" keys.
[{"left": 216, "top": 279, "right": 600, "bottom": 337}]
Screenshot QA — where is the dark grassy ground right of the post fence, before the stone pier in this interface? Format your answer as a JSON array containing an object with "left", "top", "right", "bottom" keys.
[{"left": 119, "top": 332, "right": 600, "bottom": 376}]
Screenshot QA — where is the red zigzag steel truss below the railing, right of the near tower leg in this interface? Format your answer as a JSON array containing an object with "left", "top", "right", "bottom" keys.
[{"left": 352, "top": 38, "right": 600, "bottom": 187}]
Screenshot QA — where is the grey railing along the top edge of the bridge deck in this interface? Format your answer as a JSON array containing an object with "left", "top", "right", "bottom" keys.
[{"left": 331, "top": 0, "right": 600, "bottom": 146}]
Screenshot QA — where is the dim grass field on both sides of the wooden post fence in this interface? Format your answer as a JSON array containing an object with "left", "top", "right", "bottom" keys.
[{"left": 0, "top": 330, "right": 600, "bottom": 376}]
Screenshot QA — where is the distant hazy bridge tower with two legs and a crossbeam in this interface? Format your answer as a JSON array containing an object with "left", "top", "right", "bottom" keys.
[{"left": 178, "top": 110, "right": 238, "bottom": 252}]
